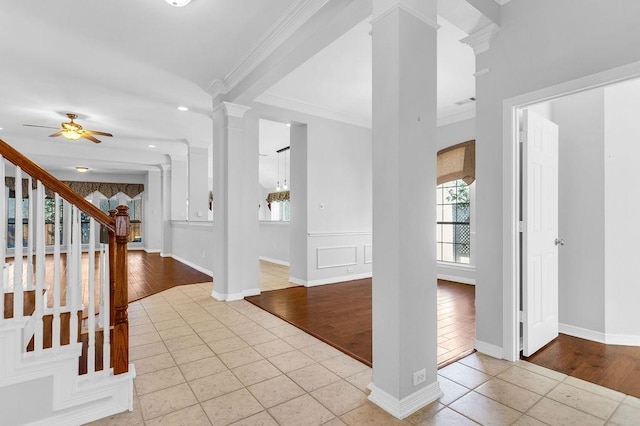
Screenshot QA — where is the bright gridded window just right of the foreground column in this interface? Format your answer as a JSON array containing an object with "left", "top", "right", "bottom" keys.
[{"left": 436, "top": 180, "right": 471, "bottom": 264}]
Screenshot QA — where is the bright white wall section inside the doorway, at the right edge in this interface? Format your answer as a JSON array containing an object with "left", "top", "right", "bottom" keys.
[{"left": 604, "top": 81, "right": 640, "bottom": 345}]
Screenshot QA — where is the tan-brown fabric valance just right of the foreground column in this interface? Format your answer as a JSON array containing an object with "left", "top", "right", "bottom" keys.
[{"left": 437, "top": 140, "right": 476, "bottom": 185}]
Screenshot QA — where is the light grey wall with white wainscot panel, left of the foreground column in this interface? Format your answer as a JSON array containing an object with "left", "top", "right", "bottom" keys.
[{"left": 247, "top": 104, "right": 372, "bottom": 285}]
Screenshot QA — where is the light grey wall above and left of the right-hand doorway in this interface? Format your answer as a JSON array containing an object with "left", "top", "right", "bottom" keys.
[{"left": 476, "top": 0, "right": 640, "bottom": 348}]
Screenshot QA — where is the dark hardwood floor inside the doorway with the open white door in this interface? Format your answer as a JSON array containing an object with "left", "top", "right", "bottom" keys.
[{"left": 523, "top": 334, "right": 640, "bottom": 398}]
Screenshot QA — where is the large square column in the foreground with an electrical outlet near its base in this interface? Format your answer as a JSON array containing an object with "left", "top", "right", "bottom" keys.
[{"left": 369, "top": 0, "right": 442, "bottom": 418}]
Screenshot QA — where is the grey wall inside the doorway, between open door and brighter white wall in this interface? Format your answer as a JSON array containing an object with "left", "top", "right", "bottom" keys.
[{"left": 546, "top": 89, "right": 610, "bottom": 337}]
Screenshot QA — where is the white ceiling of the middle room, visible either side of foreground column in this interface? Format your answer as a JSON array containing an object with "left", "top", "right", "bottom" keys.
[{"left": 256, "top": 17, "right": 475, "bottom": 127}]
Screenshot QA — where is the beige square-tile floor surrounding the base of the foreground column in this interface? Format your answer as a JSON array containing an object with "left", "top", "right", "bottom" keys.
[{"left": 93, "top": 283, "right": 640, "bottom": 426}]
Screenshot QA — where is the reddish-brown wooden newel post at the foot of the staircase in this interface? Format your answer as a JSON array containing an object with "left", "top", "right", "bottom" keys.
[{"left": 111, "top": 205, "right": 130, "bottom": 374}]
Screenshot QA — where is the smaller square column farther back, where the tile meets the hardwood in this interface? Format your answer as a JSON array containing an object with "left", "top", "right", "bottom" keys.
[{"left": 212, "top": 102, "right": 260, "bottom": 301}]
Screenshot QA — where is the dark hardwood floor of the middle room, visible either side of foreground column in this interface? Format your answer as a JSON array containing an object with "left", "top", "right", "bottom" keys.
[{"left": 246, "top": 278, "right": 475, "bottom": 367}]
